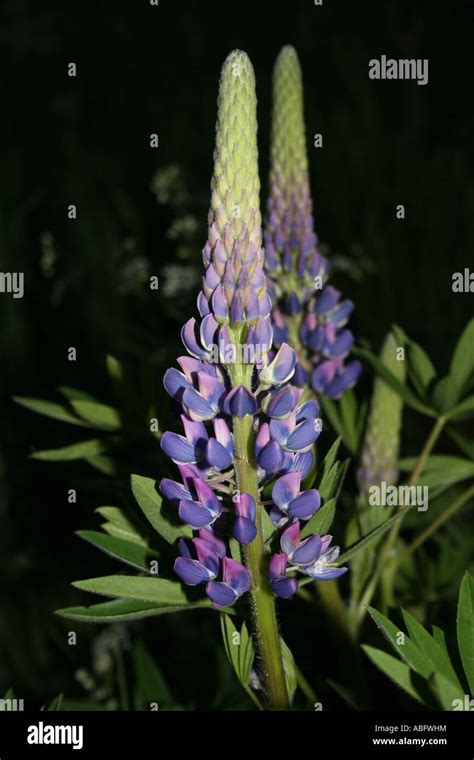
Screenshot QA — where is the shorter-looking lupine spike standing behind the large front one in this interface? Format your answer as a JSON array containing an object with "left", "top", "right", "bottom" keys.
[{"left": 265, "top": 46, "right": 361, "bottom": 398}]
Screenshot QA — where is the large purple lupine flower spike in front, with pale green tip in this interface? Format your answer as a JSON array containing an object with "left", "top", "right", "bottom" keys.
[{"left": 160, "top": 51, "right": 346, "bottom": 624}]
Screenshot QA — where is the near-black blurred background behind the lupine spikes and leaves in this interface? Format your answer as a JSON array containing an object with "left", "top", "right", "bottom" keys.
[{"left": 0, "top": 0, "right": 474, "bottom": 705}]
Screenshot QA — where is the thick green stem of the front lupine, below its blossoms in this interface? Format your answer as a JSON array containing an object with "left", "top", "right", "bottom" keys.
[{"left": 233, "top": 416, "right": 290, "bottom": 710}]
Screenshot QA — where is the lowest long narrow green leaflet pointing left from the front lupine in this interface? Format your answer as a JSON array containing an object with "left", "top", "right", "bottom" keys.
[{"left": 56, "top": 599, "right": 210, "bottom": 623}]
